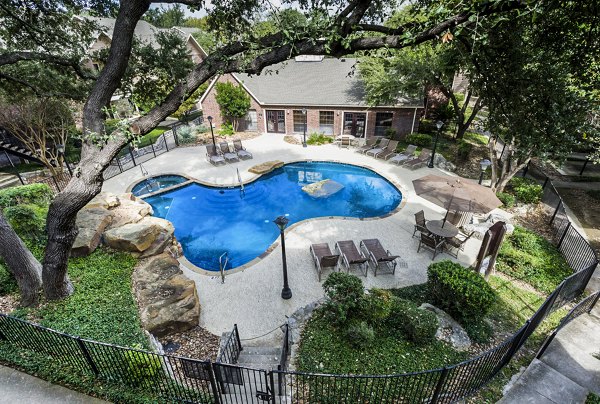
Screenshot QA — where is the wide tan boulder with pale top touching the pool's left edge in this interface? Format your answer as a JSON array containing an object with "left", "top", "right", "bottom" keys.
[{"left": 104, "top": 216, "right": 175, "bottom": 256}]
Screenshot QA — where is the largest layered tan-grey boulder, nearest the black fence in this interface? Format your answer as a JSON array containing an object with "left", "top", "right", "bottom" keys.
[{"left": 132, "top": 253, "right": 200, "bottom": 337}]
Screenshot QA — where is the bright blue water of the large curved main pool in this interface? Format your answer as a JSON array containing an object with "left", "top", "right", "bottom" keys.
[{"left": 145, "top": 162, "right": 402, "bottom": 271}]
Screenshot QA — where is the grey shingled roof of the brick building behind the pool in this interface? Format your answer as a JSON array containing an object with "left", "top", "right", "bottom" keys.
[{"left": 234, "top": 58, "right": 423, "bottom": 107}]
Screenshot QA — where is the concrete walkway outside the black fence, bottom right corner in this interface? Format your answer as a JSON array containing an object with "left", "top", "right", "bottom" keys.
[{"left": 498, "top": 304, "right": 600, "bottom": 404}]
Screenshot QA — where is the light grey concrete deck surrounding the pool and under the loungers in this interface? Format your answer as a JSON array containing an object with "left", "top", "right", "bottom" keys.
[{"left": 103, "top": 134, "right": 496, "bottom": 339}]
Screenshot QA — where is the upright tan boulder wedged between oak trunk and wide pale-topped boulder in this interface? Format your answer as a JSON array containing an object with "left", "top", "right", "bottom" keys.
[{"left": 71, "top": 205, "right": 112, "bottom": 257}]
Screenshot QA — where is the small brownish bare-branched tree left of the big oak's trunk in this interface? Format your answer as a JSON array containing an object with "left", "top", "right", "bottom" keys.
[{"left": 0, "top": 98, "right": 75, "bottom": 175}]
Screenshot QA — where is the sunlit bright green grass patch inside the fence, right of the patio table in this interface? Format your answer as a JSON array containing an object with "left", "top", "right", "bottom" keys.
[{"left": 496, "top": 226, "right": 572, "bottom": 294}]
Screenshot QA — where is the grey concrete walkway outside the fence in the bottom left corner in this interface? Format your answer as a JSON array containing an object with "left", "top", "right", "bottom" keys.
[{"left": 0, "top": 366, "right": 106, "bottom": 404}]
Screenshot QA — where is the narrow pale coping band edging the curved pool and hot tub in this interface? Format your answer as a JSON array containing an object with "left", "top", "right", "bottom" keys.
[{"left": 127, "top": 159, "right": 408, "bottom": 277}]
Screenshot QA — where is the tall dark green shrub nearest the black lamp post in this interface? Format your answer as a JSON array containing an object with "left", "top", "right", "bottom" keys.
[{"left": 323, "top": 272, "right": 364, "bottom": 325}]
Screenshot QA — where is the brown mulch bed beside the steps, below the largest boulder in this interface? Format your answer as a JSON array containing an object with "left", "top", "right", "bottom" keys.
[{"left": 160, "top": 327, "right": 219, "bottom": 361}]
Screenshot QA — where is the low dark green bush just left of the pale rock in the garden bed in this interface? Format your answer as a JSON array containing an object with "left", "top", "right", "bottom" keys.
[{"left": 387, "top": 298, "right": 438, "bottom": 344}]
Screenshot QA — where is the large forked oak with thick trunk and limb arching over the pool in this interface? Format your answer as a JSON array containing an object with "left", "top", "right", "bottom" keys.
[{"left": 0, "top": 0, "right": 529, "bottom": 300}]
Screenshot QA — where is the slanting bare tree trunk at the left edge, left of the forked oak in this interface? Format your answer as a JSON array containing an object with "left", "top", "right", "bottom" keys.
[{"left": 0, "top": 212, "right": 42, "bottom": 307}]
